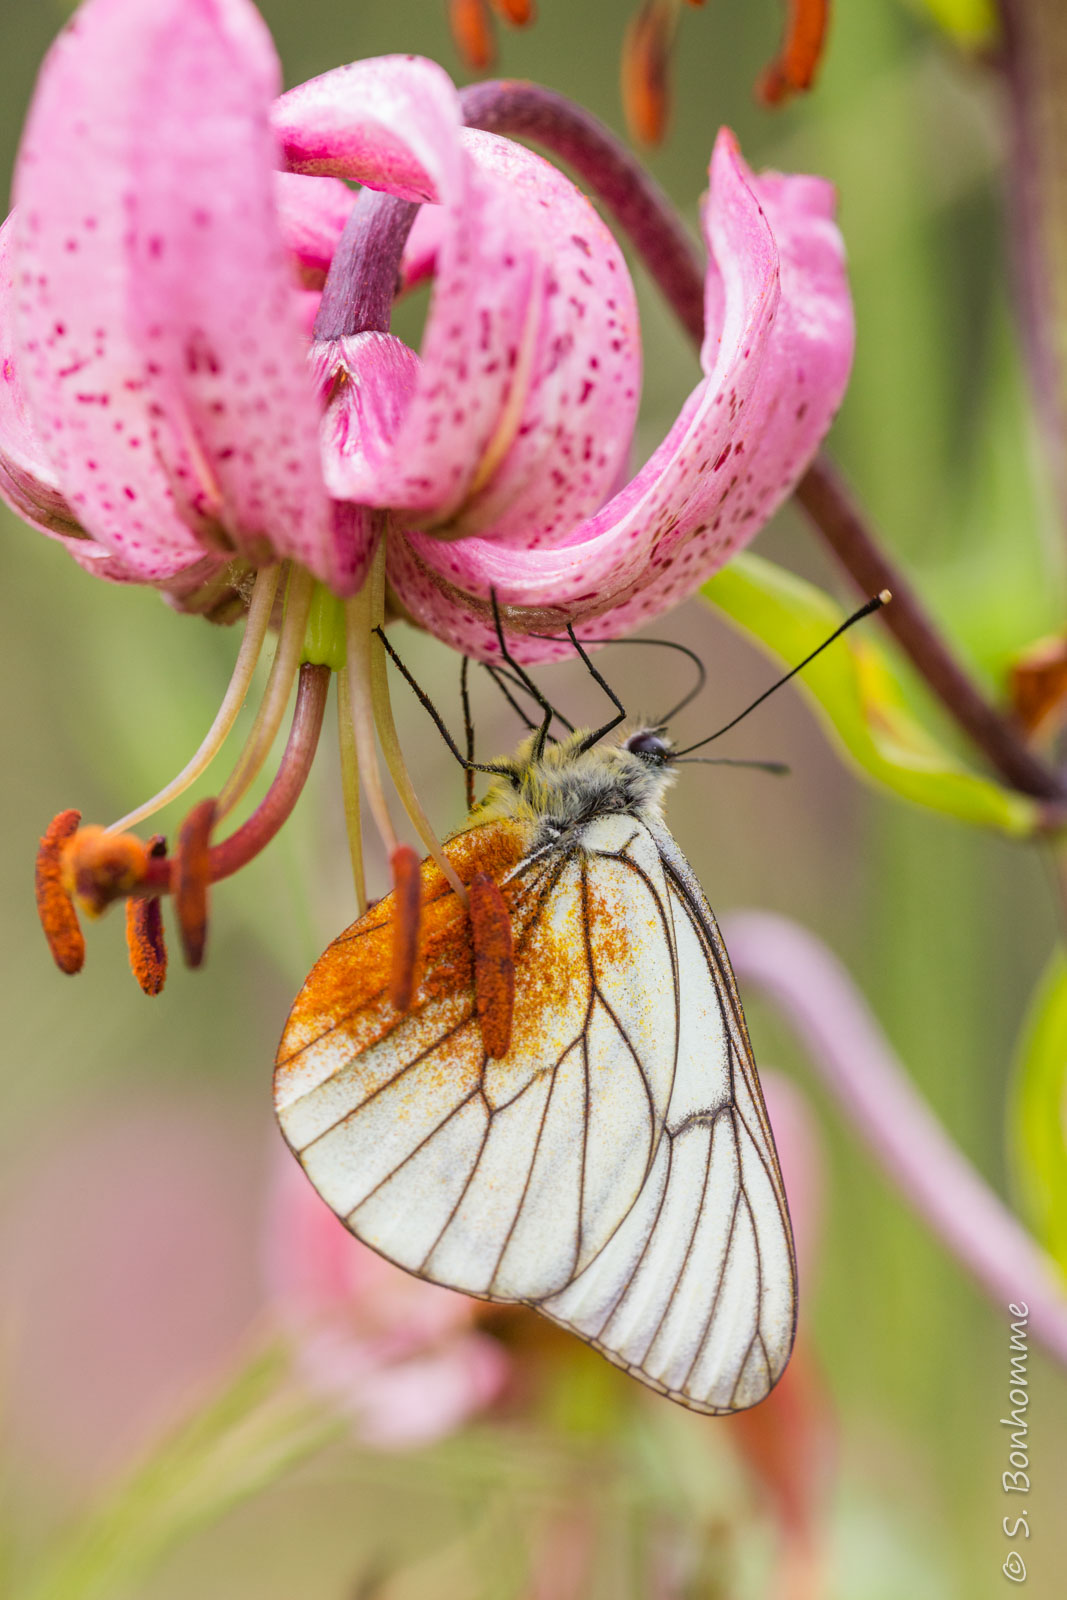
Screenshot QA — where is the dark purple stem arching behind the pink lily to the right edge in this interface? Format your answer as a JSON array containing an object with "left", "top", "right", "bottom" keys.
[{"left": 461, "top": 81, "right": 1067, "bottom": 800}]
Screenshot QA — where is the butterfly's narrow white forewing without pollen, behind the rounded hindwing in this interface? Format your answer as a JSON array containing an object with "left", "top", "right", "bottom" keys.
[{"left": 539, "top": 824, "right": 797, "bottom": 1413}]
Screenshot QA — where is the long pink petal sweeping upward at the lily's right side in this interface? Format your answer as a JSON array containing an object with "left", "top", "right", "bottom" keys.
[{"left": 389, "top": 131, "right": 853, "bottom": 661}]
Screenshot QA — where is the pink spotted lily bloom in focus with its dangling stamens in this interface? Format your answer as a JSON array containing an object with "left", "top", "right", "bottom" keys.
[{"left": 0, "top": 0, "right": 853, "bottom": 992}]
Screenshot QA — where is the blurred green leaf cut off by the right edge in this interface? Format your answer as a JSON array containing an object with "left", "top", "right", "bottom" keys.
[{"left": 1009, "top": 949, "right": 1067, "bottom": 1272}]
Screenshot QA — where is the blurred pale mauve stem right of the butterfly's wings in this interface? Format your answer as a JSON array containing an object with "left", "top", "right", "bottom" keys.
[{"left": 726, "top": 912, "right": 1067, "bottom": 1366}]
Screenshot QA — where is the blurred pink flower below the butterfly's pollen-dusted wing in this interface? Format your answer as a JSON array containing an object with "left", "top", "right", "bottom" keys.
[{"left": 264, "top": 1155, "right": 509, "bottom": 1450}]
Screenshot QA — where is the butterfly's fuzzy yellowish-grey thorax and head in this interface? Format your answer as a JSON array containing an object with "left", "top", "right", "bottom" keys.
[{"left": 474, "top": 726, "right": 673, "bottom": 848}]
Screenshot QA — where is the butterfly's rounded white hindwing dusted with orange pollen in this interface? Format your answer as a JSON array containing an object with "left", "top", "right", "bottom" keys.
[{"left": 275, "top": 818, "right": 677, "bottom": 1301}]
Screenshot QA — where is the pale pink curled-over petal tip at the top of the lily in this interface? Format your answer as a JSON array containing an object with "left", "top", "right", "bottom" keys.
[{"left": 272, "top": 56, "right": 462, "bottom": 200}]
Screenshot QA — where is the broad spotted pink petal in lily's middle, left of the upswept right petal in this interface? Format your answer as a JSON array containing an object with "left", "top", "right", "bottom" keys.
[{"left": 316, "top": 130, "right": 640, "bottom": 549}]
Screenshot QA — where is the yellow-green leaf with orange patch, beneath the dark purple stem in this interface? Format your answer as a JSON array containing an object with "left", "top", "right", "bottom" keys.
[{"left": 701, "top": 555, "right": 1040, "bottom": 838}]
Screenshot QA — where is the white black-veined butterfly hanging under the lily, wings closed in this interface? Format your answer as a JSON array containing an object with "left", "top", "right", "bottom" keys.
[{"left": 275, "top": 597, "right": 883, "bottom": 1414}]
